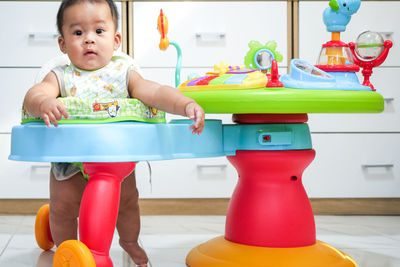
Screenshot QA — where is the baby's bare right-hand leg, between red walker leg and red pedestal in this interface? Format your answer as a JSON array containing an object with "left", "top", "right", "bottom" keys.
[{"left": 117, "top": 172, "right": 148, "bottom": 267}]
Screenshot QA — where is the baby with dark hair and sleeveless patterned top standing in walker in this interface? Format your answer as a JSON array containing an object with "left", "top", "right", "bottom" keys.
[{"left": 24, "top": 0, "right": 204, "bottom": 266}]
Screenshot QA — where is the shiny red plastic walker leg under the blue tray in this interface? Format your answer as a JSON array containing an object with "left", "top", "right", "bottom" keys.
[{"left": 79, "top": 162, "right": 135, "bottom": 267}]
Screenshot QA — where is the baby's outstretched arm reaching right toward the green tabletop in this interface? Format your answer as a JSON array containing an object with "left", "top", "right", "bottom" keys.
[{"left": 129, "top": 70, "right": 204, "bottom": 134}]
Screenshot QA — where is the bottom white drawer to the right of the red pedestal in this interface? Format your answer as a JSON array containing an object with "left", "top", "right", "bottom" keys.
[{"left": 303, "top": 134, "right": 400, "bottom": 198}]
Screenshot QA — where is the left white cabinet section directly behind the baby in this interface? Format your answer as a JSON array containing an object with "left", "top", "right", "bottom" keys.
[{"left": 0, "top": 1, "right": 121, "bottom": 199}]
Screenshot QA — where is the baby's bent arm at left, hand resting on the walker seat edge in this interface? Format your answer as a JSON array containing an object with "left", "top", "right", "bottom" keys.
[{"left": 24, "top": 72, "right": 68, "bottom": 127}]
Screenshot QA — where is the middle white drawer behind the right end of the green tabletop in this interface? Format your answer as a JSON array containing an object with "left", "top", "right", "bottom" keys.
[{"left": 309, "top": 67, "right": 400, "bottom": 132}]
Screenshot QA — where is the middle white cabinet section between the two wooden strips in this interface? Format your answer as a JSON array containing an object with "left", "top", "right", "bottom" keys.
[{"left": 133, "top": 1, "right": 288, "bottom": 198}]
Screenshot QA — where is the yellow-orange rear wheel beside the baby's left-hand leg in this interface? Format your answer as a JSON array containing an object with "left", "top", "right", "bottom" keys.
[{"left": 35, "top": 204, "right": 54, "bottom": 250}]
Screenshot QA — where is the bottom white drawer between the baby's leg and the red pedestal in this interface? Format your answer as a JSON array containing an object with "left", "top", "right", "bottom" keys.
[{"left": 136, "top": 157, "right": 237, "bottom": 198}]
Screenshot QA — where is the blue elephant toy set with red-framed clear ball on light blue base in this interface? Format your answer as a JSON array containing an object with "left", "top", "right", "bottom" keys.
[{"left": 281, "top": 1, "right": 393, "bottom": 91}]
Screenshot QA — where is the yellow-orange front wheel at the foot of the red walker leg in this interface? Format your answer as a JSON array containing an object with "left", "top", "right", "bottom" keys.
[{"left": 53, "top": 240, "right": 96, "bottom": 267}]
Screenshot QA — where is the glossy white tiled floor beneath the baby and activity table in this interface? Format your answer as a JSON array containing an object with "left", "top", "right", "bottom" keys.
[{"left": 0, "top": 216, "right": 400, "bottom": 267}]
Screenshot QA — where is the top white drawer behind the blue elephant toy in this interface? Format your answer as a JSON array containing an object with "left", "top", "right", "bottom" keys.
[{"left": 299, "top": 1, "right": 400, "bottom": 66}]
